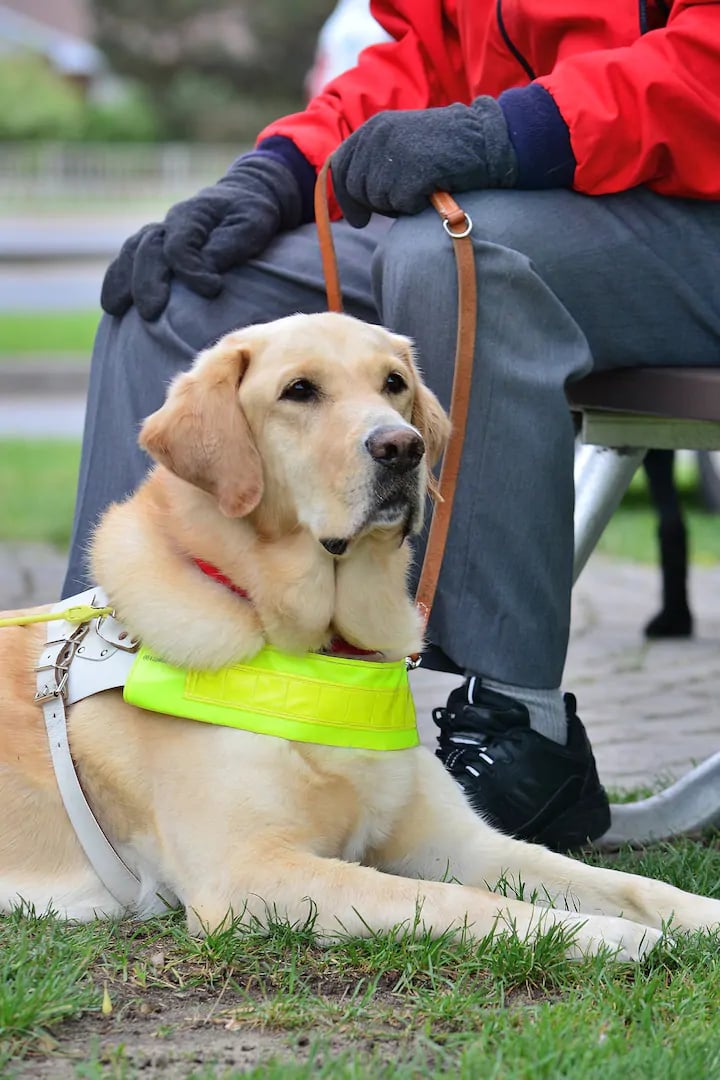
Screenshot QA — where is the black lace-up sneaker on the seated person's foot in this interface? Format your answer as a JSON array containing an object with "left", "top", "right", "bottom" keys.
[{"left": 433, "top": 678, "right": 610, "bottom": 851}]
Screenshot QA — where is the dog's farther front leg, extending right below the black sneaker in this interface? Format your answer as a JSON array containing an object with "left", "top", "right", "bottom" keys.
[{"left": 375, "top": 750, "right": 720, "bottom": 930}]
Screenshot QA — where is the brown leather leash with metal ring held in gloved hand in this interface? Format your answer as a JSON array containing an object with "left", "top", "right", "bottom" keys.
[{"left": 315, "top": 160, "right": 477, "bottom": 639}]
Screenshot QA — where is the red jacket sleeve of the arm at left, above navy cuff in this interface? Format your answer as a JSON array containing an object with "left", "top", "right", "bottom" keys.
[{"left": 258, "top": 0, "right": 470, "bottom": 170}]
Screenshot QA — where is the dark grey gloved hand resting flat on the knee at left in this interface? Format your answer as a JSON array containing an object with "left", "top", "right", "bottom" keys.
[{"left": 100, "top": 152, "right": 302, "bottom": 321}]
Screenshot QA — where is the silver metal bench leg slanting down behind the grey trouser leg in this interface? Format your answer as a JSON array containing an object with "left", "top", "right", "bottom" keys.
[{"left": 573, "top": 444, "right": 647, "bottom": 582}]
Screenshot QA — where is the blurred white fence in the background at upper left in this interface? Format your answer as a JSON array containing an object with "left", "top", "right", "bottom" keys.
[{"left": 0, "top": 143, "right": 242, "bottom": 204}]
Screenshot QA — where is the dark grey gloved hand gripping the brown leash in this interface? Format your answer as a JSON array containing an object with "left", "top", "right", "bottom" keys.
[{"left": 330, "top": 96, "right": 517, "bottom": 229}]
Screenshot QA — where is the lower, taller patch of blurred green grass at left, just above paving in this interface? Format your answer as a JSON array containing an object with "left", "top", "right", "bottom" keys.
[{"left": 0, "top": 438, "right": 80, "bottom": 549}]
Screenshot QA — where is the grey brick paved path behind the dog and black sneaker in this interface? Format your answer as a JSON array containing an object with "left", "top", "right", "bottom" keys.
[{"left": 0, "top": 544, "right": 720, "bottom": 787}]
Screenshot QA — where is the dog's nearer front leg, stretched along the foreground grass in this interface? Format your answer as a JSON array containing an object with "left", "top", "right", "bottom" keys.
[{"left": 177, "top": 843, "right": 658, "bottom": 960}]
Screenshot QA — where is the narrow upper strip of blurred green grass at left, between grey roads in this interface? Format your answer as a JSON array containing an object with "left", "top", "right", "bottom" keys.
[{"left": 0, "top": 311, "right": 100, "bottom": 360}]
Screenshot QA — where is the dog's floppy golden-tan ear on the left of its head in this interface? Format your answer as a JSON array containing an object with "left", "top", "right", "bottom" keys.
[{"left": 139, "top": 334, "right": 262, "bottom": 517}]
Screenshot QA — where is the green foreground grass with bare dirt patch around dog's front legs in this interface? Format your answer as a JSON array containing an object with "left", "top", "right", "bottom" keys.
[{"left": 0, "top": 836, "right": 720, "bottom": 1080}]
